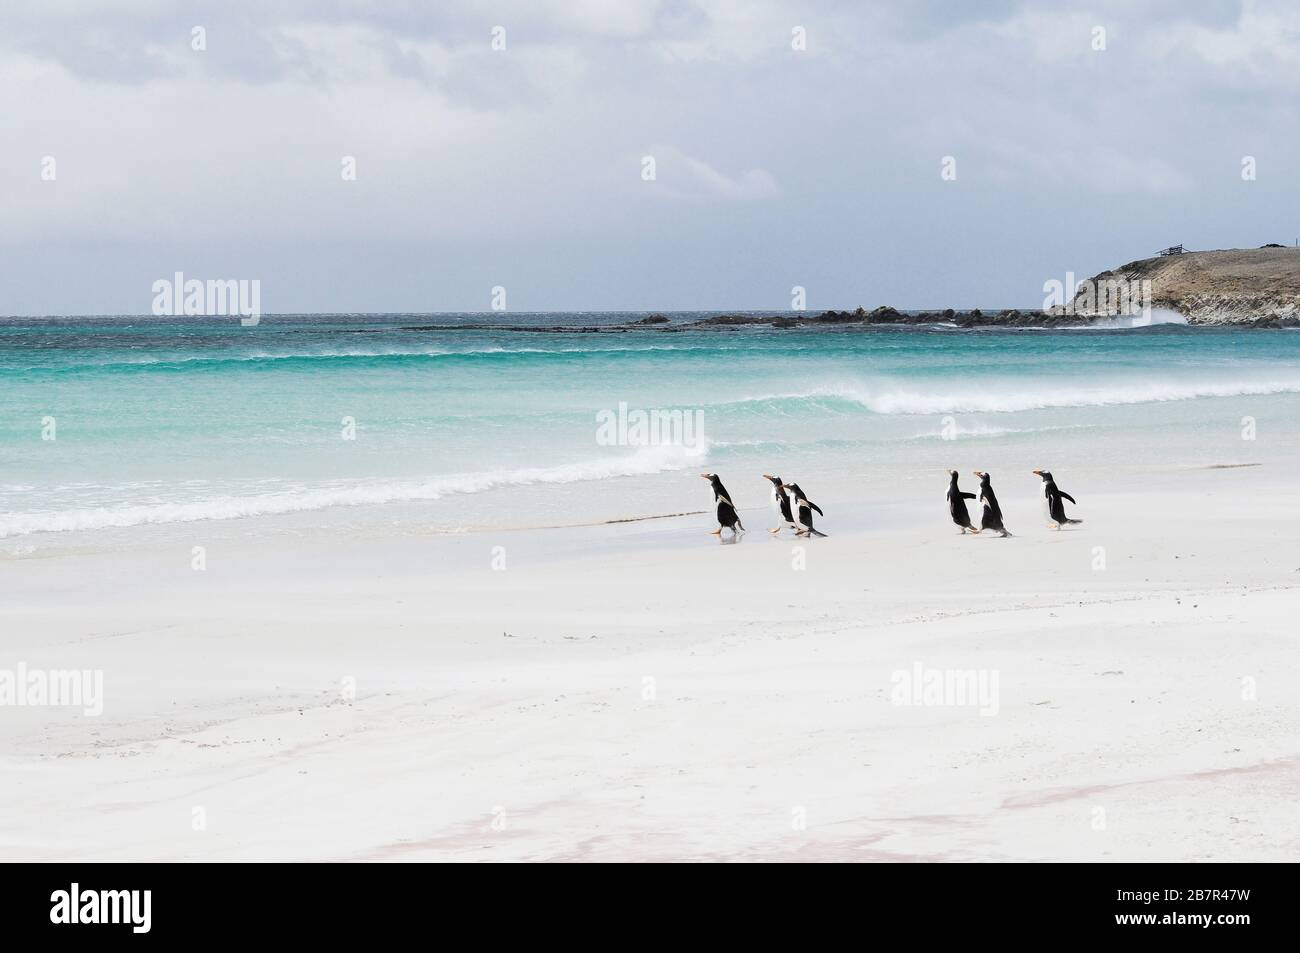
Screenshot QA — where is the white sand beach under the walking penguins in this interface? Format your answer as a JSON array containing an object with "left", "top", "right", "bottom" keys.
[{"left": 0, "top": 463, "right": 1300, "bottom": 861}]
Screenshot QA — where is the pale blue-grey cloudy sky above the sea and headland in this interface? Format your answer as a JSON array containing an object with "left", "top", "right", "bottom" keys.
[{"left": 0, "top": 0, "right": 1300, "bottom": 315}]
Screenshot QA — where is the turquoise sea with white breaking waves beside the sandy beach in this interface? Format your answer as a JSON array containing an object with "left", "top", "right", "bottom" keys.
[{"left": 0, "top": 313, "right": 1300, "bottom": 555}]
